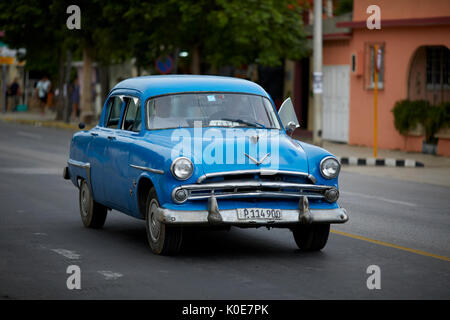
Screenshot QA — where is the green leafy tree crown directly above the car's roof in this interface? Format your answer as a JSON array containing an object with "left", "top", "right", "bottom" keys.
[{"left": 125, "top": 0, "right": 306, "bottom": 74}]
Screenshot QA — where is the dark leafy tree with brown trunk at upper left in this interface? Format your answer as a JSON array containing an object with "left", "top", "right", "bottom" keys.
[{"left": 0, "top": 0, "right": 132, "bottom": 122}]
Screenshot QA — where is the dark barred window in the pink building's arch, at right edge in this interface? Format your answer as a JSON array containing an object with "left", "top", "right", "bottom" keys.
[{"left": 427, "top": 46, "right": 450, "bottom": 90}]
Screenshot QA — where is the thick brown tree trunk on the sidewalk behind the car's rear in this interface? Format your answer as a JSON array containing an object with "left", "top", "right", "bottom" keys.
[{"left": 80, "top": 47, "right": 94, "bottom": 124}]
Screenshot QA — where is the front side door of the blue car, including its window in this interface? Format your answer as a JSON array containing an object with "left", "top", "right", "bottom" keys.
[{"left": 105, "top": 96, "right": 141, "bottom": 213}]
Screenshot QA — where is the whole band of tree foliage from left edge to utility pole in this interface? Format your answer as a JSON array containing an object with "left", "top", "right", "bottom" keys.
[{"left": 0, "top": 0, "right": 306, "bottom": 70}]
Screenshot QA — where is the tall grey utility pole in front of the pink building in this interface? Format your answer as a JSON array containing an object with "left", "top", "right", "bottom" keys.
[{"left": 313, "top": 0, "right": 323, "bottom": 146}]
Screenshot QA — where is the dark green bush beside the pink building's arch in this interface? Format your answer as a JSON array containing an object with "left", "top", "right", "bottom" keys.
[{"left": 392, "top": 100, "right": 450, "bottom": 143}]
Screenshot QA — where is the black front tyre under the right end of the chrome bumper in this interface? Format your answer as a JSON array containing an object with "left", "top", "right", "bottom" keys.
[{"left": 292, "top": 224, "right": 330, "bottom": 251}]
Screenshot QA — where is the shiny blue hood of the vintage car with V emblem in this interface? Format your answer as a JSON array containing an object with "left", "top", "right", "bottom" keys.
[{"left": 148, "top": 128, "right": 309, "bottom": 174}]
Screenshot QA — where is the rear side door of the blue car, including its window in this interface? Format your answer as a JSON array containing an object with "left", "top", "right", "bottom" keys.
[{"left": 89, "top": 96, "right": 123, "bottom": 205}]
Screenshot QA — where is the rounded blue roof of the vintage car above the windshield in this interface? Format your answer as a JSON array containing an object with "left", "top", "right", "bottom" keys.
[{"left": 111, "top": 75, "right": 269, "bottom": 99}]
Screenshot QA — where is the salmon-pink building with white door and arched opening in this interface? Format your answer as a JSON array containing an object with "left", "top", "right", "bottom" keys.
[{"left": 293, "top": 0, "right": 450, "bottom": 156}]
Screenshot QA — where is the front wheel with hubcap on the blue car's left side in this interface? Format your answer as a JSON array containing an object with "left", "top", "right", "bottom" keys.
[{"left": 145, "top": 188, "right": 183, "bottom": 255}]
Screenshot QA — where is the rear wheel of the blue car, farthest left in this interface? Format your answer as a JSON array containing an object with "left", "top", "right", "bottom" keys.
[{"left": 79, "top": 180, "right": 108, "bottom": 229}]
